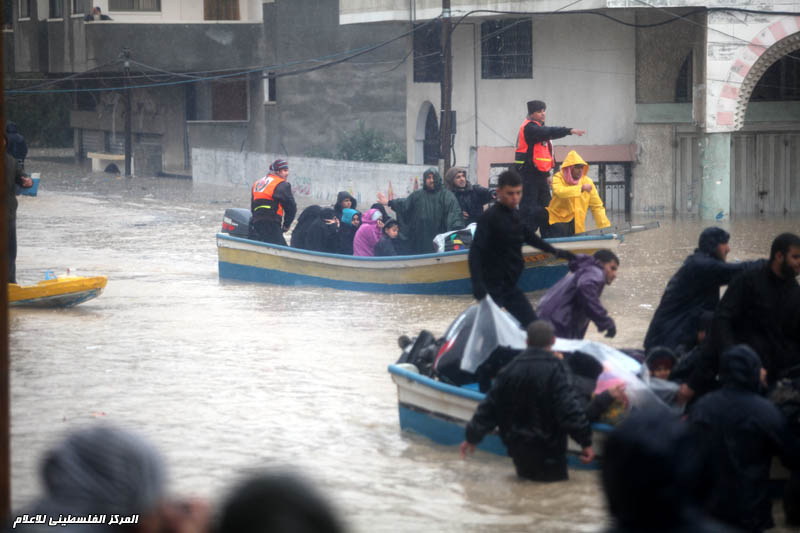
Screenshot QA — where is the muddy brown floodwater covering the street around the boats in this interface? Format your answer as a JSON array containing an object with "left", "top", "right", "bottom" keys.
[{"left": 10, "top": 152, "right": 800, "bottom": 533}]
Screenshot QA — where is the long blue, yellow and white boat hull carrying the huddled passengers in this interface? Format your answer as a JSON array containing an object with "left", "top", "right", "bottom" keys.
[{"left": 217, "top": 233, "right": 621, "bottom": 294}]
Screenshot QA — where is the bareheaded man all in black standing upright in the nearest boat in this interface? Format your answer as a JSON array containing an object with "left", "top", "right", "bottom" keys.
[{"left": 469, "top": 170, "right": 575, "bottom": 328}]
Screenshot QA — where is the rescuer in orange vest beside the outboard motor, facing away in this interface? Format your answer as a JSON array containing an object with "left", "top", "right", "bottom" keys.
[{"left": 250, "top": 159, "right": 297, "bottom": 246}]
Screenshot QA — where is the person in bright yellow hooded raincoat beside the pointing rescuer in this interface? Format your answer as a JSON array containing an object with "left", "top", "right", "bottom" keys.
[{"left": 547, "top": 150, "right": 611, "bottom": 237}]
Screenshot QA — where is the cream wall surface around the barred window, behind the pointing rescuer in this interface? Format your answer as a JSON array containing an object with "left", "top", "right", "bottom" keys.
[{"left": 406, "top": 12, "right": 635, "bottom": 163}]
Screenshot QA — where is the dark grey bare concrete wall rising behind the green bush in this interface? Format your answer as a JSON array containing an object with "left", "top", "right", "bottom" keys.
[{"left": 262, "top": 0, "right": 408, "bottom": 156}]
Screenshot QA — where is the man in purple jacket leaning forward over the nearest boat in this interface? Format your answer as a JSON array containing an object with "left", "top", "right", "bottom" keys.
[{"left": 538, "top": 254, "right": 615, "bottom": 339}]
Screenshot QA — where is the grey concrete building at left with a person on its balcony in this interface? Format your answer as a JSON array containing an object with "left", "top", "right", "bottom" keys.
[{"left": 3, "top": 0, "right": 408, "bottom": 173}]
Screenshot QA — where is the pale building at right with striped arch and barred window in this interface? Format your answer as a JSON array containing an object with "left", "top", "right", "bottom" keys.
[{"left": 339, "top": 0, "right": 800, "bottom": 219}]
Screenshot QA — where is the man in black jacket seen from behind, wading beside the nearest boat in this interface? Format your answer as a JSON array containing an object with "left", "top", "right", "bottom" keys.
[{"left": 461, "top": 320, "right": 594, "bottom": 481}]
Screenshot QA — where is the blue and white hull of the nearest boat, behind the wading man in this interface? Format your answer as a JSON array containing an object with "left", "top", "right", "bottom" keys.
[{"left": 389, "top": 364, "right": 613, "bottom": 470}]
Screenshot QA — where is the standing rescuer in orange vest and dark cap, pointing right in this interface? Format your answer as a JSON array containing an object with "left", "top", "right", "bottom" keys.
[{"left": 514, "top": 100, "right": 586, "bottom": 231}]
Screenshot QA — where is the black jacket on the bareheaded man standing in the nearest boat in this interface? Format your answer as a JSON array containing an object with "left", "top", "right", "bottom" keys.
[{"left": 469, "top": 202, "right": 558, "bottom": 300}]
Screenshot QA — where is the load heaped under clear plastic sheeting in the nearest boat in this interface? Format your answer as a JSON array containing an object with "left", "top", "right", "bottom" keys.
[{"left": 397, "top": 296, "right": 678, "bottom": 424}]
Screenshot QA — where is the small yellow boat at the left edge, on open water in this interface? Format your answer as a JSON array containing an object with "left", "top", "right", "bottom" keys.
[{"left": 8, "top": 276, "right": 108, "bottom": 307}]
